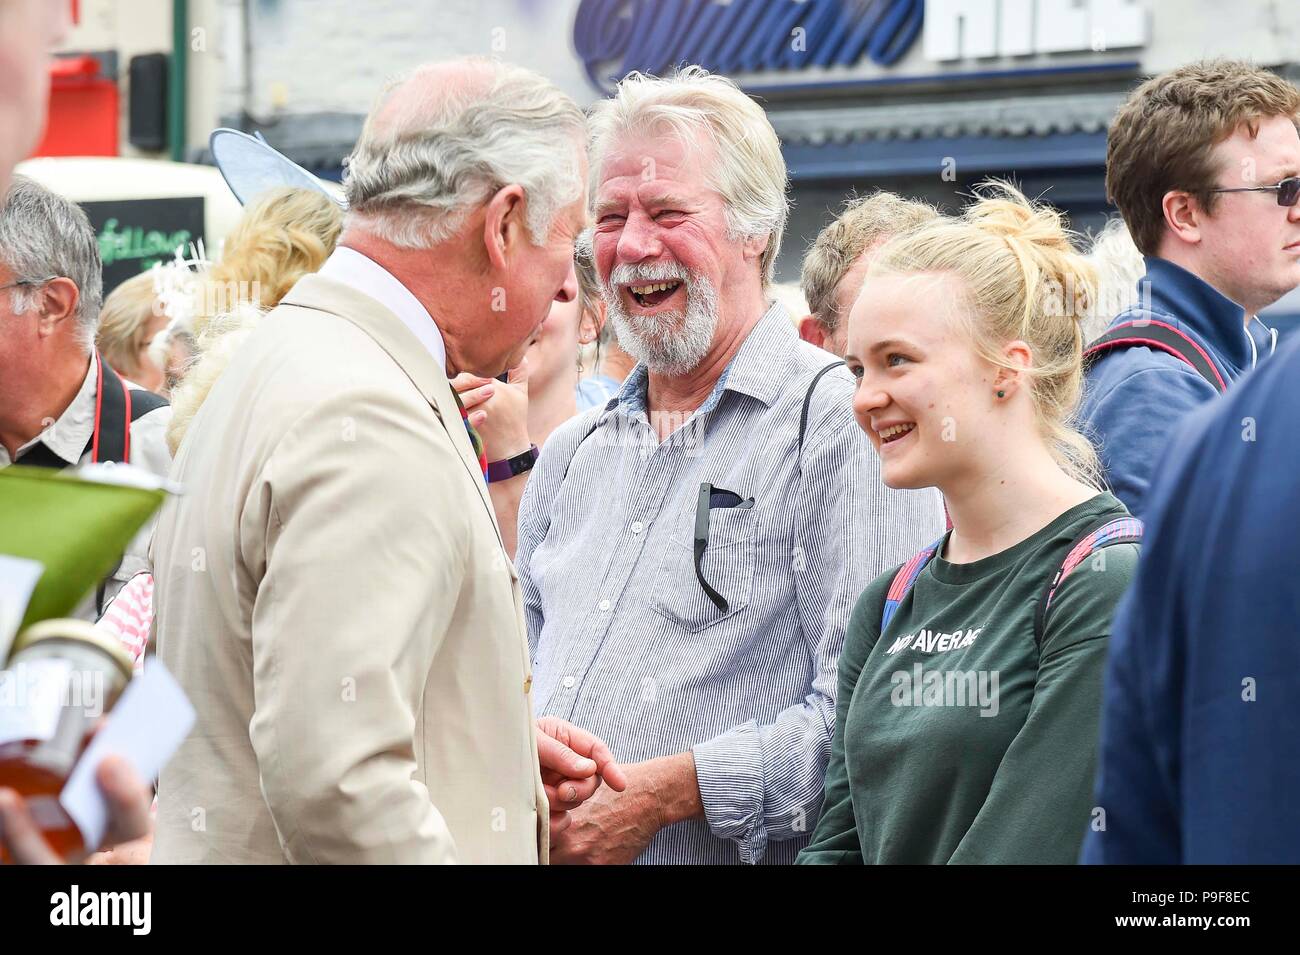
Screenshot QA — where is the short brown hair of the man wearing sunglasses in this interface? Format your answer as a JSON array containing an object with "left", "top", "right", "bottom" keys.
[{"left": 1106, "top": 60, "right": 1300, "bottom": 256}]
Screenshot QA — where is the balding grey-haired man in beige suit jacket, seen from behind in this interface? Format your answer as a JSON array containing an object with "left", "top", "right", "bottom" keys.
[{"left": 152, "top": 60, "right": 623, "bottom": 863}]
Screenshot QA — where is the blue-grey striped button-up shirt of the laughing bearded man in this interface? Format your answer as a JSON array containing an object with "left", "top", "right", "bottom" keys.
[{"left": 517, "top": 305, "right": 944, "bottom": 863}]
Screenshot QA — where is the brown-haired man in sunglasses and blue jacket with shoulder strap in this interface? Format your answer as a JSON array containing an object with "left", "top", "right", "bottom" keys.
[{"left": 1082, "top": 60, "right": 1300, "bottom": 516}]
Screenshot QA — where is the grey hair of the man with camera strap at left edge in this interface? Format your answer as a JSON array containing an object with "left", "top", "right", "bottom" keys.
[{"left": 0, "top": 175, "right": 104, "bottom": 351}]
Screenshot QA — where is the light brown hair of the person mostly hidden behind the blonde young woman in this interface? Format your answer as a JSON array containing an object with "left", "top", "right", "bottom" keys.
[{"left": 800, "top": 191, "right": 939, "bottom": 335}]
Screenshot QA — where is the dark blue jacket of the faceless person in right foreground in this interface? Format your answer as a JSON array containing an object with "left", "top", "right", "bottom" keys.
[{"left": 1083, "top": 340, "right": 1300, "bottom": 864}]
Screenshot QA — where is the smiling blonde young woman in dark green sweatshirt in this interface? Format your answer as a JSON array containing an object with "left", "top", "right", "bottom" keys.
[{"left": 800, "top": 185, "right": 1140, "bottom": 864}]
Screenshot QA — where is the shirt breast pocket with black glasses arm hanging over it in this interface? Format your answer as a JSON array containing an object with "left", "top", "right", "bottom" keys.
[{"left": 650, "top": 508, "right": 758, "bottom": 633}]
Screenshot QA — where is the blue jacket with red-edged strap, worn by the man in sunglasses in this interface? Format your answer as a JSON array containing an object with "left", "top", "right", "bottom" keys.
[{"left": 1079, "top": 256, "right": 1277, "bottom": 517}]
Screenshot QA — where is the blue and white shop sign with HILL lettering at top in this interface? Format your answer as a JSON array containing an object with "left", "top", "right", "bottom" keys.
[{"left": 573, "top": 0, "right": 1149, "bottom": 92}]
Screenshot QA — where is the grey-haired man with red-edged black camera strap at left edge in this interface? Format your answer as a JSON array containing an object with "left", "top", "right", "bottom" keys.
[{"left": 0, "top": 175, "right": 172, "bottom": 620}]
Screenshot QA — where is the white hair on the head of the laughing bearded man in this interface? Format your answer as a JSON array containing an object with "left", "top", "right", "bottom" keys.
[{"left": 589, "top": 66, "right": 789, "bottom": 287}]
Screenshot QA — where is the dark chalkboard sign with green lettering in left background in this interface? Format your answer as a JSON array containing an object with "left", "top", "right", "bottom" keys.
[{"left": 81, "top": 196, "right": 204, "bottom": 295}]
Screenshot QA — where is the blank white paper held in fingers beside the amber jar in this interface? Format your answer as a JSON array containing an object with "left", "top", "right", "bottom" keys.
[{"left": 59, "top": 657, "right": 194, "bottom": 850}]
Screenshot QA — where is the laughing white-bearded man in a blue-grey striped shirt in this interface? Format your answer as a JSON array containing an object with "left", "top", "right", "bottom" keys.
[{"left": 517, "top": 68, "right": 944, "bottom": 863}]
